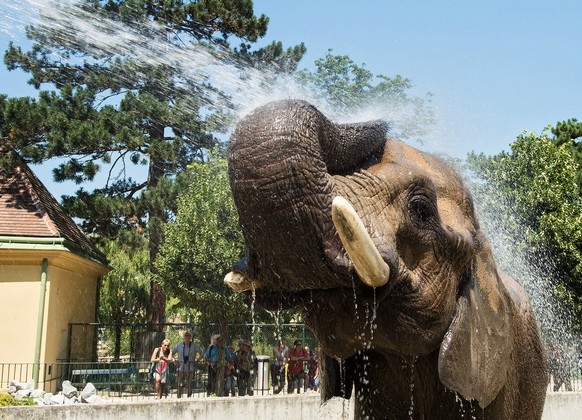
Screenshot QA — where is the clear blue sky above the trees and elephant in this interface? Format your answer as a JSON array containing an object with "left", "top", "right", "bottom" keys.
[{"left": 0, "top": 0, "right": 582, "bottom": 195}]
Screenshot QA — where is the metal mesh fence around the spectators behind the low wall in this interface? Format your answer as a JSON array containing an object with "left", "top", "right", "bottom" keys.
[{"left": 0, "top": 323, "right": 582, "bottom": 399}]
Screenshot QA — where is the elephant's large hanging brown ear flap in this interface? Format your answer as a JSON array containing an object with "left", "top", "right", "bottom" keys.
[{"left": 439, "top": 231, "right": 513, "bottom": 408}]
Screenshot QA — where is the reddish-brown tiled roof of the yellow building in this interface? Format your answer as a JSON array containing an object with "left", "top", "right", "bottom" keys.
[{"left": 0, "top": 149, "right": 107, "bottom": 265}]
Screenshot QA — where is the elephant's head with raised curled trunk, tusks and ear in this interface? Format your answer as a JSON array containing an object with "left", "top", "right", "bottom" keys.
[{"left": 225, "top": 101, "right": 543, "bottom": 418}]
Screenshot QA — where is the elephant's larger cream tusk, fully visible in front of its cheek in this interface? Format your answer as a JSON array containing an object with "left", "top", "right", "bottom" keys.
[{"left": 331, "top": 196, "right": 390, "bottom": 287}]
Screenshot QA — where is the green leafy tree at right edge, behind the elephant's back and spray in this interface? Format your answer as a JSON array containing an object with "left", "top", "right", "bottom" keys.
[{"left": 468, "top": 133, "right": 582, "bottom": 319}]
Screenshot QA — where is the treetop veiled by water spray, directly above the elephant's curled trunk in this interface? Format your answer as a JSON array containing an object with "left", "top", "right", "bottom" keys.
[{"left": 297, "top": 50, "right": 434, "bottom": 137}]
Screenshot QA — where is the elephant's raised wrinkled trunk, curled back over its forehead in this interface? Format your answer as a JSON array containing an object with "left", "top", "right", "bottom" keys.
[{"left": 228, "top": 101, "right": 387, "bottom": 291}]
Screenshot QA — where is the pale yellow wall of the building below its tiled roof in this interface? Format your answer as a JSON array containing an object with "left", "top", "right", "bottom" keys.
[{"left": 0, "top": 247, "right": 107, "bottom": 364}]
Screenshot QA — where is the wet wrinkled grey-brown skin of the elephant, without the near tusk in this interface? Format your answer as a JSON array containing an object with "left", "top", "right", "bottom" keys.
[{"left": 229, "top": 101, "right": 547, "bottom": 419}]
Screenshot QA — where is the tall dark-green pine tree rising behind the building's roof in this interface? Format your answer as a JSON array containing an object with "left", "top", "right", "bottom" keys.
[{"left": 0, "top": 0, "right": 305, "bottom": 330}]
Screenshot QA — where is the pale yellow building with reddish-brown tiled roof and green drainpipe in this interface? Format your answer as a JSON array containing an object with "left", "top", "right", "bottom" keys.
[{"left": 0, "top": 150, "right": 109, "bottom": 384}]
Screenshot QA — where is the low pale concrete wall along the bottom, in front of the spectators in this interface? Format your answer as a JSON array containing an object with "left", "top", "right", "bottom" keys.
[{"left": 0, "top": 392, "right": 582, "bottom": 420}]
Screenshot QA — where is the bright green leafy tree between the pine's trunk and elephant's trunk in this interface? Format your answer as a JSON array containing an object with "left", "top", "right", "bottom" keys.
[{"left": 156, "top": 152, "right": 251, "bottom": 323}]
